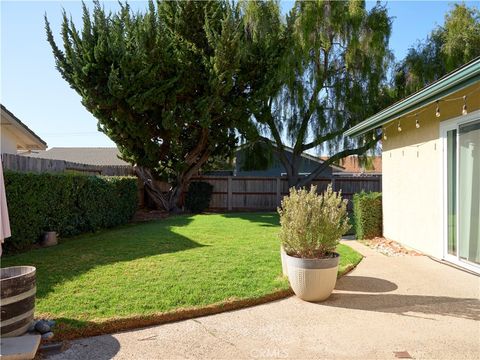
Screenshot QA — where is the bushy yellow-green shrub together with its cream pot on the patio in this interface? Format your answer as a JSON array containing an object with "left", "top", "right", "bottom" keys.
[{"left": 278, "top": 185, "right": 350, "bottom": 301}]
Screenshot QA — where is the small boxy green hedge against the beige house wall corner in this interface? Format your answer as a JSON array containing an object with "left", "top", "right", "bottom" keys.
[{"left": 353, "top": 192, "right": 382, "bottom": 239}]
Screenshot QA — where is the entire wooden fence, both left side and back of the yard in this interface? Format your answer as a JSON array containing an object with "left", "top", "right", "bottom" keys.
[{"left": 1, "top": 154, "right": 382, "bottom": 211}]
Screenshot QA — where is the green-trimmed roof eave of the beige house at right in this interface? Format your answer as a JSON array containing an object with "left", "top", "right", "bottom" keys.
[{"left": 345, "top": 57, "right": 480, "bottom": 136}]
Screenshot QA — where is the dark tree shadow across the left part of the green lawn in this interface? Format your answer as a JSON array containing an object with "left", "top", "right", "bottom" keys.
[{"left": 2, "top": 216, "right": 203, "bottom": 299}]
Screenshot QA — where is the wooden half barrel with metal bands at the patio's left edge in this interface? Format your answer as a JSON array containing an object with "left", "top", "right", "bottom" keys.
[{"left": 0, "top": 266, "right": 37, "bottom": 337}]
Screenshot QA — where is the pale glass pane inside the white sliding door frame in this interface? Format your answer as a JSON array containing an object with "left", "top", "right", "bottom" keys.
[{"left": 458, "top": 121, "right": 480, "bottom": 264}]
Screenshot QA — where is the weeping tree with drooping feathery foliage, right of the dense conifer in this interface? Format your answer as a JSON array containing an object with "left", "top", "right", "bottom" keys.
[{"left": 245, "top": 1, "right": 391, "bottom": 187}]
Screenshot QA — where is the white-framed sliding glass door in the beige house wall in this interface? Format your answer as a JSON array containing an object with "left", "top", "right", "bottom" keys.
[{"left": 444, "top": 114, "right": 480, "bottom": 269}]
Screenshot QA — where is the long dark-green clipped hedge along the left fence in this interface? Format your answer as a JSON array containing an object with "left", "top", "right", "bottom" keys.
[{"left": 4, "top": 171, "right": 137, "bottom": 252}]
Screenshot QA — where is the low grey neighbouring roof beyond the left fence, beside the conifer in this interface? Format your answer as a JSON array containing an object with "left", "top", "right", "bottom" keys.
[{"left": 27, "top": 147, "right": 130, "bottom": 166}]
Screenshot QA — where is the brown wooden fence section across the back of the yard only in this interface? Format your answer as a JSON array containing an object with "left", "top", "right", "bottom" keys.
[{"left": 189, "top": 175, "right": 382, "bottom": 211}]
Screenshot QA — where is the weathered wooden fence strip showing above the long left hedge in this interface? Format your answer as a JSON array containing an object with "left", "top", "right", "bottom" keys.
[{"left": 1, "top": 154, "right": 135, "bottom": 176}]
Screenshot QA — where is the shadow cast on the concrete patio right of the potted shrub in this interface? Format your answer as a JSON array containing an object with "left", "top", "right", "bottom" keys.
[{"left": 324, "top": 276, "right": 480, "bottom": 321}]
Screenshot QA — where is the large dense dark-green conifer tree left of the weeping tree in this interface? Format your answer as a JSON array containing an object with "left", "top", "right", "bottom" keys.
[{"left": 45, "top": 1, "right": 248, "bottom": 211}]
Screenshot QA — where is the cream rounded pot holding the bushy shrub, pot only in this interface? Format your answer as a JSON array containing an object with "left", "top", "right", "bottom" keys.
[{"left": 285, "top": 253, "right": 340, "bottom": 301}]
